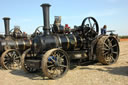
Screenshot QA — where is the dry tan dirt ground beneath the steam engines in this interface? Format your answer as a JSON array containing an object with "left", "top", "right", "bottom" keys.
[{"left": 0, "top": 41, "right": 128, "bottom": 85}]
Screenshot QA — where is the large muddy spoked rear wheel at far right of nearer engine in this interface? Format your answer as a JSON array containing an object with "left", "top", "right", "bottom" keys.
[{"left": 96, "top": 36, "right": 119, "bottom": 65}]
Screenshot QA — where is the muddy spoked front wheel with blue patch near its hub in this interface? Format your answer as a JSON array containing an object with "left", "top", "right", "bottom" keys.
[{"left": 42, "top": 48, "right": 69, "bottom": 79}]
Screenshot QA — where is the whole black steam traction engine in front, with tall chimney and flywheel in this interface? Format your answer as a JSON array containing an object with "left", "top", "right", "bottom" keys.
[{"left": 21, "top": 4, "right": 119, "bottom": 79}]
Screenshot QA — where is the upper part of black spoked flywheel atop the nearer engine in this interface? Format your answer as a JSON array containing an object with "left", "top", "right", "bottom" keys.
[{"left": 81, "top": 17, "right": 99, "bottom": 35}]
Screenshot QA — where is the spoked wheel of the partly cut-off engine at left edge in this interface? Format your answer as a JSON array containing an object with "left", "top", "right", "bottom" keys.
[{"left": 0, "top": 49, "right": 21, "bottom": 70}]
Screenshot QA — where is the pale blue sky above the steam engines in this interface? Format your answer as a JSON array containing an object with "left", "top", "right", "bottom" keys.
[{"left": 0, "top": 0, "right": 128, "bottom": 35}]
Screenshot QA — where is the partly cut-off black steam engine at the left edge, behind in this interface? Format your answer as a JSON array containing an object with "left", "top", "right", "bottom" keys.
[{"left": 0, "top": 17, "right": 32, "bottom": 69}]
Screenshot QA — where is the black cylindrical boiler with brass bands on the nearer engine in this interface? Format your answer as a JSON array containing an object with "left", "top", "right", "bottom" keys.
[{"left": 32, "top": 34, "right": 83, "bottom": 52}]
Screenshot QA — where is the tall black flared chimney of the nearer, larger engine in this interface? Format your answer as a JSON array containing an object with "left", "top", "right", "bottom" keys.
[{"left": 41, "top": 4, "right": 51, "bottom": 35}]
